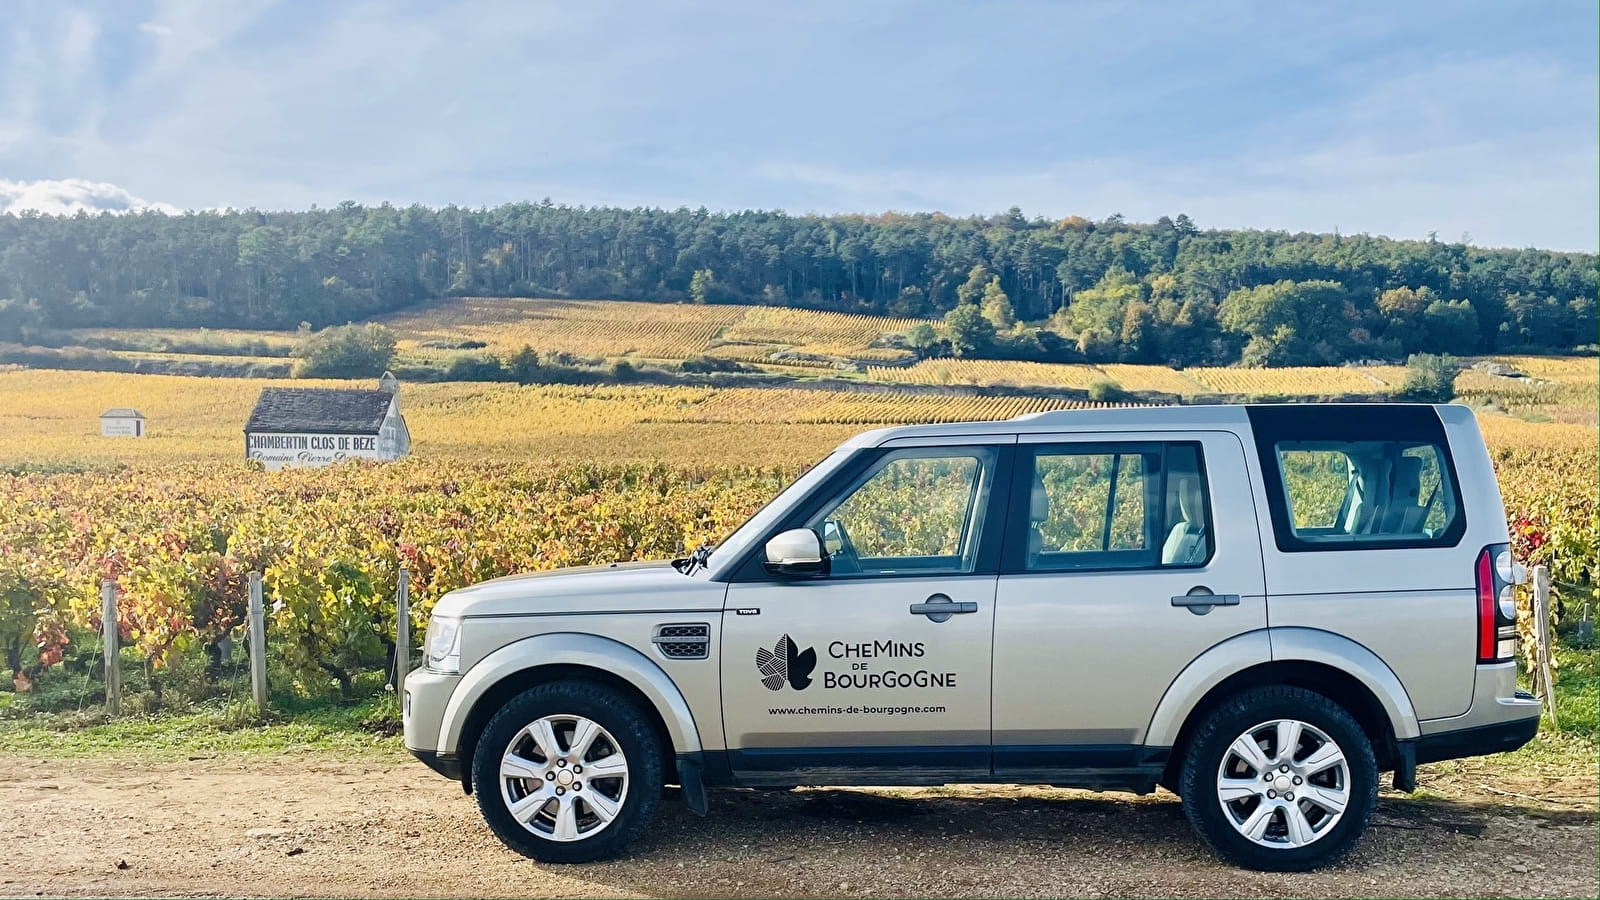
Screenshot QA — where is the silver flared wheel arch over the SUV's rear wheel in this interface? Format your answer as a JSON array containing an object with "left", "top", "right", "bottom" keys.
[{"left": 1146, "top": 628, "right": 1421, "bottom": 783}]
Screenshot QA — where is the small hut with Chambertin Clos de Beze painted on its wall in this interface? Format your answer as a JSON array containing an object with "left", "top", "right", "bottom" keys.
[{"left": 245, "top": 372, "right": 411, "bottom": 469}]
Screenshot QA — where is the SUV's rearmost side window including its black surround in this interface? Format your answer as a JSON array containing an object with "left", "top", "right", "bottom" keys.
[{"left": 1250, "top": 405, "right": 1466, "bottom": 551}]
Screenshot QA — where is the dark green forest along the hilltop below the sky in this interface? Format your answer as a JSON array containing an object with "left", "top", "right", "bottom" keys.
[{"left": 0, "top": 202, "right": 1597, "bottom": 365}]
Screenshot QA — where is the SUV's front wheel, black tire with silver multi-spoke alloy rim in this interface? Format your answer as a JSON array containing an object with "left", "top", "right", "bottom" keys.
[{"left": 472, "top": 681, "right": 664, "bottom": 863}]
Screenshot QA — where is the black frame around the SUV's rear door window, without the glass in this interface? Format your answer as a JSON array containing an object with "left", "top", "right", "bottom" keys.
[{"left": 1000, "top": 436, "right": 1216, "bottom": 575}]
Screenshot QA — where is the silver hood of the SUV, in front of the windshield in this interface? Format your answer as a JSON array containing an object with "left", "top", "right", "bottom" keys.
[{"left": 434, "top": 560, "right": 728, "bottom": 617}]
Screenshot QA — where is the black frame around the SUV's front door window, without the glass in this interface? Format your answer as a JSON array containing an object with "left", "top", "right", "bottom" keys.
[{"left": 726, "top": 440, "right": 1016, "bottom": 585}]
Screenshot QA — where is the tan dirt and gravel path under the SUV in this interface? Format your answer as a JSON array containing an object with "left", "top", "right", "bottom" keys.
[{"left": 0, "top": 753, "right": 1597, "bottom": 897}]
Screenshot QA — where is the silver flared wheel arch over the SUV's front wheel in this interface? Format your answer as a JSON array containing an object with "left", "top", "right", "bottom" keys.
[{"left": 438, "top": 633, "right": 701, "bottom": 790}]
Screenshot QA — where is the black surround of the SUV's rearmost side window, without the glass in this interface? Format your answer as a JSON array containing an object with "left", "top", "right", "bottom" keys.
[{"left": 1245, "top": 404, "right": 1467, "bottom": 552}]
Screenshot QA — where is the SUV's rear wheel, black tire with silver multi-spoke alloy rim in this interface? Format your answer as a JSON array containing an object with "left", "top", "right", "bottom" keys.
[{"left": 1179, "top": 687, "right": 1378, "bottom": 871}]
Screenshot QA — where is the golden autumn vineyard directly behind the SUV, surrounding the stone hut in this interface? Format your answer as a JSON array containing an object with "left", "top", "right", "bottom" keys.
[{"left": 0, "top": 372, "right": 1597, "bottom": 689}]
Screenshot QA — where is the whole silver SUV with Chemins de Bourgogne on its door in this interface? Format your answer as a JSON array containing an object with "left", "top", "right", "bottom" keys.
[{"left": 405, "top": 405, "right": 1539, "bottom": 870}]
